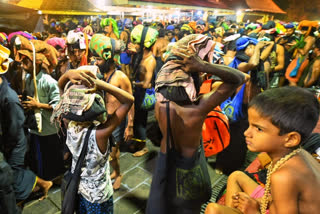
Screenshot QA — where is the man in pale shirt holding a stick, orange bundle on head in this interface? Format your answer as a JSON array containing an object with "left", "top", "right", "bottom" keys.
[{"left": 15, "top": 37, "right": 63, "bottom": 180}]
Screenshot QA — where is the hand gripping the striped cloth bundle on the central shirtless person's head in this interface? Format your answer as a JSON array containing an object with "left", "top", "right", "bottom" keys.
[{"left": 172, "top": 48, "right": 205, "bottom": 73}]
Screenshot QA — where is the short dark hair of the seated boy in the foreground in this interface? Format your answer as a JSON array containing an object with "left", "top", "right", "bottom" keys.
[{"left": 249, "top": 86, "right": 319, "bottom": 142}]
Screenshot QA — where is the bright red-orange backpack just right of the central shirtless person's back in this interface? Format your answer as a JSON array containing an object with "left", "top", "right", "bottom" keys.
[{"left": 200, "top": 79, "right": 230, "bottom": 157}]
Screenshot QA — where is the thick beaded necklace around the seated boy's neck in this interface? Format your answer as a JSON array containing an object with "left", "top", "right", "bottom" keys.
[{"left": 260, "top": 148, "right": 301, "bottom": 214}]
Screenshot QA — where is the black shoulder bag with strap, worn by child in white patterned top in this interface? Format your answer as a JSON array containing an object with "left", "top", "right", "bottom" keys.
[{"left": 61, "top": 126, "right": 93, "bottom": 214}]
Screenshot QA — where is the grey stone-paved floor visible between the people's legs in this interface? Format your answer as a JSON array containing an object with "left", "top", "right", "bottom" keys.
[{"left": 22, "top": 111, "right": 255, "bottom": 214}]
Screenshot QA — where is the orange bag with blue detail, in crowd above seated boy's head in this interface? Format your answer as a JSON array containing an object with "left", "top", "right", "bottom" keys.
[{"left": 285, "top": 56, "right": 309, "bottom": 83}]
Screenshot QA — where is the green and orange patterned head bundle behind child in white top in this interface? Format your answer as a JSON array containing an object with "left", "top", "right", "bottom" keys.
[{"left": 89, "top": 34, "right": 126, "bottom": 65}]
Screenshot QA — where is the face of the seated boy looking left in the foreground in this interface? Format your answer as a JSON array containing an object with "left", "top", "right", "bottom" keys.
[{"left": 244, "top": 107, "right": 287, "bottom": 153}]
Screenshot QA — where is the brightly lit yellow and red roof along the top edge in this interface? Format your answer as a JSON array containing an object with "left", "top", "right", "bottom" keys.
[{"left": 4, "top": 0, "right": 285, "bottom": 15}]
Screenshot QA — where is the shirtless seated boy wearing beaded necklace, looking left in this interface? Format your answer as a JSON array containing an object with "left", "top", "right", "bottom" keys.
[{"left": 205, "top": 87, "right": 320, "bottom": 214}]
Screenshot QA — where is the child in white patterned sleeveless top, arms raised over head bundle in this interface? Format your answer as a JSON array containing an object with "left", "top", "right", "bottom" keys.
[{"left": 53, "top": 70, "right": 134, "bottom": 214}]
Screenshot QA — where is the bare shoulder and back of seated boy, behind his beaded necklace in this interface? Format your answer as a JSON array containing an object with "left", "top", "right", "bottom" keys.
[{"left": 270, "top": 150, "right": 320, "bottom": 214}]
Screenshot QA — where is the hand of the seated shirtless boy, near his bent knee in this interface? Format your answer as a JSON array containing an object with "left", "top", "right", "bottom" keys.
[{"left": 232, "top": 192, "right": 260, "bottom": 214}]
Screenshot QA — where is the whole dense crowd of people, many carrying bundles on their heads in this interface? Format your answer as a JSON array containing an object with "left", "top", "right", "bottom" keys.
[{"left": 0, "top": 13, "right": 320, "bottom": 214}]
